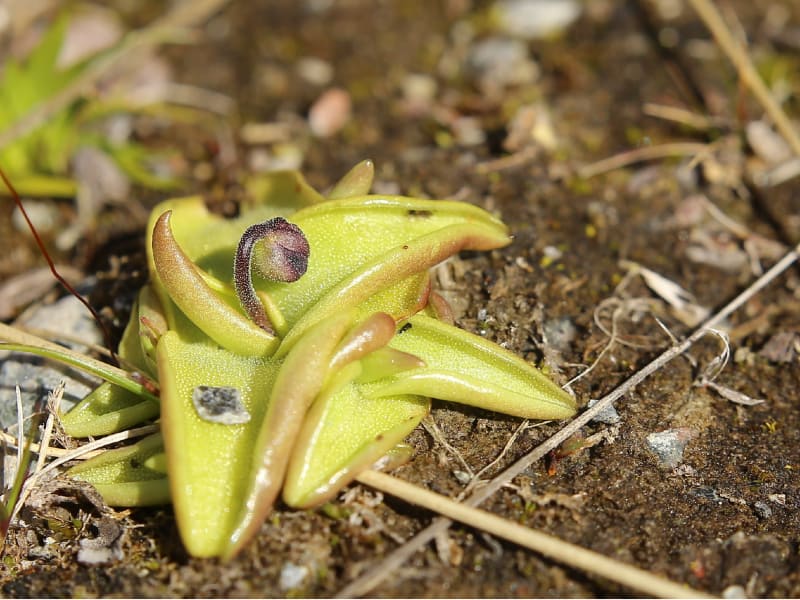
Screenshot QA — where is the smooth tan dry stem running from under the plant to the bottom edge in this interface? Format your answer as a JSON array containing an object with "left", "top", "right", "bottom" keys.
[{"left": 357, "top": 471, "right": 711, "bottom": 598}]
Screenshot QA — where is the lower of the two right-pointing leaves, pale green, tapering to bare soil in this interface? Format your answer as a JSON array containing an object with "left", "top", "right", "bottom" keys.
[{"left": 370, "top": 315, "right": 576, "bottom": 419}]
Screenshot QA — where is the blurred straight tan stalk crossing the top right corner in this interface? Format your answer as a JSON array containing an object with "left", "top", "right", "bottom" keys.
[{"left": 689, "top": 0, "right": 800, "bottom": 156}]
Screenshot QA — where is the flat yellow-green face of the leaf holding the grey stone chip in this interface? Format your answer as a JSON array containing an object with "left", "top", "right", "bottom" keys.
[{"left": 157, "top": 313, "right": 280, "bottom": 556}]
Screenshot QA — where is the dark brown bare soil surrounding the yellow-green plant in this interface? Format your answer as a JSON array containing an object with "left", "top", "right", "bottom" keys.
[{"left": 0, "top": 0, "right": 800, "bottom": 597}]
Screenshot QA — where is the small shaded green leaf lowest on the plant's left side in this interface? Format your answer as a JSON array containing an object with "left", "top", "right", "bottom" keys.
[{"left": 67, "top": 433, "right": 170, "bottom": 506}]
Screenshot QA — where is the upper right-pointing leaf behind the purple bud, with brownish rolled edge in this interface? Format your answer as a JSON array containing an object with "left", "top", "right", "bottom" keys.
[{"left": 268, "top": 196, "right": 510, "bottom": 327}]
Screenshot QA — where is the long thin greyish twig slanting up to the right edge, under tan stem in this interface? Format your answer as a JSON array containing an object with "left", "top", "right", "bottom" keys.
[{"left": 336, "top": 245, "right": 800, "bottom": 598}]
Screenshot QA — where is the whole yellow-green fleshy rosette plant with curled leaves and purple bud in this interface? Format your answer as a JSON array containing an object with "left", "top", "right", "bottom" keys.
[{"left": 20, "top": 161, "right": 575, "bottom": 557}]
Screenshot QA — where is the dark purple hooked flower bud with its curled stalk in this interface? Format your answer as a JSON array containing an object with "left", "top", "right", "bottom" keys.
[{"left": 233, "top": 217, "right": 311, "bottom": 334}]
